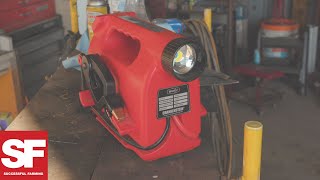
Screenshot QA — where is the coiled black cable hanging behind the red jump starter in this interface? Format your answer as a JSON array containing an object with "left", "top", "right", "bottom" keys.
[{"left": 184, "top": 20, "right": 233, "bottom": 179}]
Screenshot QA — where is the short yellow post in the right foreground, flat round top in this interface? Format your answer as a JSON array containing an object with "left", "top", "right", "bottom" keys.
[{"left": 242, "top": 121, "right": 263, "bottom": 180}]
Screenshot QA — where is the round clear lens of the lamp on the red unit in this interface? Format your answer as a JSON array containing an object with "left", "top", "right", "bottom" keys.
[{"left": 173, "top": 45, "right": 197, "bottom": 74}]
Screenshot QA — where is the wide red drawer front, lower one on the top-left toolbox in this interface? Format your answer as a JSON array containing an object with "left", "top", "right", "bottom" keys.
[{"left": 0, "top": 0, "right": 56, "bottom": 32}]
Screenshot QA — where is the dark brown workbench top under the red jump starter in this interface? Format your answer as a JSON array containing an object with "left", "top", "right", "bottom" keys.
[{"left": 8, "top": 68, "right": 218, "bottom": 180}]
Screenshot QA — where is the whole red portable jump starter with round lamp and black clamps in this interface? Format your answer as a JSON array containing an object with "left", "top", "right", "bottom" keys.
[{"left": 79, "top": 12, "right": 206, "bottom": 161}]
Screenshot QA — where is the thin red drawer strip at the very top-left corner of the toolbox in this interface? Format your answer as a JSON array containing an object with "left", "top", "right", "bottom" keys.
[{"left": 0, "top": 0, "right": 52, "bottom": 11}]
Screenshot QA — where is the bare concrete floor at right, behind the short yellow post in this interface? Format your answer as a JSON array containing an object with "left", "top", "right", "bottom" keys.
[{"left": 230, "top": 85, "right": 320, "bottom": 180}]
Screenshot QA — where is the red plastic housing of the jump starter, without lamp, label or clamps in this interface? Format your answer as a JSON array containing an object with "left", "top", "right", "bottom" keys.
[{"left": 84, "top": 13, "right": 206, "bottom": 161}]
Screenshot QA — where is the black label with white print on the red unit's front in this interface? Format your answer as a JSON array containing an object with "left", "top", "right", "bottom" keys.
[{"left": 157, "top": 85, "right": 190, "bottom": 119}]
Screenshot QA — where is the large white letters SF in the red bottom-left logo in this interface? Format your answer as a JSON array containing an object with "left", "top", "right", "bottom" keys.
[{"left": 1, "top": 139, "right": 46, "bottom": 169}]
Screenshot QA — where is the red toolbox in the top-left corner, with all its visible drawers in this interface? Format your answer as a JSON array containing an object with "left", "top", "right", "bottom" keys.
[{"left": 0, "top": 0, "right": 56, "bottom": 32}]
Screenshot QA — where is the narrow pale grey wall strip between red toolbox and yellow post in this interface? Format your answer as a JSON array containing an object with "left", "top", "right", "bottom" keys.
[{"left": 55, "top": 0, "right": 71, "bottom": 32}]
